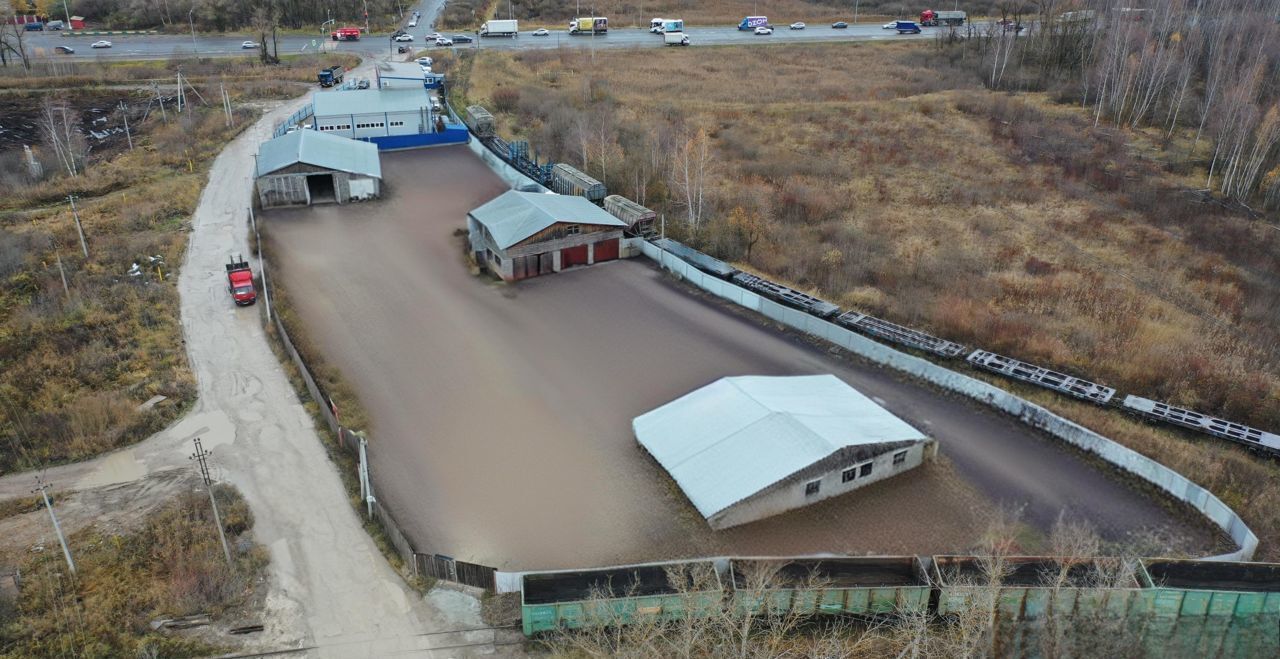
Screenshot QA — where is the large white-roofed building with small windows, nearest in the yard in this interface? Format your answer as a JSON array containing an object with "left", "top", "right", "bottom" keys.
[{"left": 631, "top": 375, "right": 937, "bottom": 530}]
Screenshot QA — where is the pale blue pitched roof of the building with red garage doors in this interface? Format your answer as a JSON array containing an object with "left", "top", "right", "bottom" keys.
[{"left": 468, "top": 189, "right": 626, "bottom": 250}]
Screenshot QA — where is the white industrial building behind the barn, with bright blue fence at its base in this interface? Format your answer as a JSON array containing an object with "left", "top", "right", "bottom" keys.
[{"left": 312, "top": 86, "right": 470, "bottom": 151}]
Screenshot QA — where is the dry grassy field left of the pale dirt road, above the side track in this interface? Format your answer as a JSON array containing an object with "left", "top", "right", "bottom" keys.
[{"left": 0, "top": 58, "right": 358, "bottom": 473}]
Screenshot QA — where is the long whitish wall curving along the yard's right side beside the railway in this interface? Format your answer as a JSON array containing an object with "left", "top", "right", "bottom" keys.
[{"left": 641, "top": 242, "right": 1258, "bottom": 560}]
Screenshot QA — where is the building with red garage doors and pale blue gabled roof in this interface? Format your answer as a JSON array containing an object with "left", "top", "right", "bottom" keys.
[{"left": 467, "top": 191, "right": 626, "bottom": 282}]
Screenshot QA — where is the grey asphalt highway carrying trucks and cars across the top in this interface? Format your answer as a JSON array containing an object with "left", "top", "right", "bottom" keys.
[{"left": 26, "top": 21, "right": 962, "bottom": 60}]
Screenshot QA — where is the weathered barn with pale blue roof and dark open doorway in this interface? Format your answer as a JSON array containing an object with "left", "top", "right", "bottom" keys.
[{"left": 255, "top": 131, "right": 383, "bottom": 209}]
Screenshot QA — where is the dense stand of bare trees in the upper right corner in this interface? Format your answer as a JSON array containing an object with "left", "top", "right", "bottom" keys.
[{"left": 962, "top": 0, "right": 1280, "bottom": 209}]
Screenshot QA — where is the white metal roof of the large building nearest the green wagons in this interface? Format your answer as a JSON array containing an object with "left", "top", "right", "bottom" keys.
[{"left": 631, "top": 375, "right": 925, "bottom": 517}]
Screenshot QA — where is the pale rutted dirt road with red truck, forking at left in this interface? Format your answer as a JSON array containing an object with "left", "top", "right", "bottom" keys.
[{"left": 0, "top": 85, "right": 519, "bottom": 658}]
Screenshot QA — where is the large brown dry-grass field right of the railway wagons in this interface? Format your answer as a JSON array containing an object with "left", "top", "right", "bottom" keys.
[{"left": 460, "top": 44, "right": 1280, "bottom": 555}]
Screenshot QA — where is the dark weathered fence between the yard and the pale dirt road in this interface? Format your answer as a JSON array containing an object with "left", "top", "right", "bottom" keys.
[{"left": 251, "top": 217, "right": 497, "bottom": 590}]
